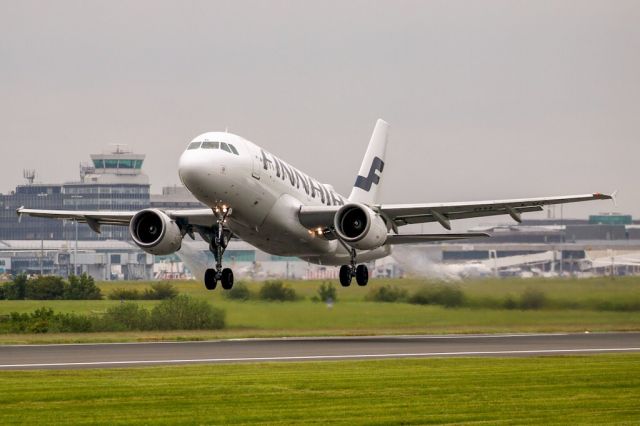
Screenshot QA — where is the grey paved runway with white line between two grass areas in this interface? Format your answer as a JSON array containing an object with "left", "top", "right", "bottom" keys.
[{"left": 0, "top": 333, "right": 640, "bottom": 370}]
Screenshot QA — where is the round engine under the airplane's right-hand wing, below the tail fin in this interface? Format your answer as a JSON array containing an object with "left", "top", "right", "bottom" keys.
[{"left": 334, "top": 203, "right": 387, "bottom": 250}]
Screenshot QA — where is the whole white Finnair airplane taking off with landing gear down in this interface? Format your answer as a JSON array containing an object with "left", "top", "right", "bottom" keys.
[{"left": 17, "top": 119, "right": 612, "bottom": 290}]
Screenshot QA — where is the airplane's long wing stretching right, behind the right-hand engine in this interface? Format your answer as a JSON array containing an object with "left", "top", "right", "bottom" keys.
[{"left": 298, "top": 193, "right": 613, "bottom": 231}]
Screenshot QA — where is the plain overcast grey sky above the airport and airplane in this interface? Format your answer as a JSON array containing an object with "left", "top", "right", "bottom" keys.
[{"left": 0, "top": 0, "right": 640, "bottom": 228}]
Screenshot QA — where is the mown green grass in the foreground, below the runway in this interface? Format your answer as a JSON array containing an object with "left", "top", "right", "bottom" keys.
[{"left": 0, "top": 355, "right": 640, "bottom": 424}]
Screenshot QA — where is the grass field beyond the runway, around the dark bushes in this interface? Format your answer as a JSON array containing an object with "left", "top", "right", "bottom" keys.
[{"left": 0, "top": 278, "right": 640, "bottom": 343}]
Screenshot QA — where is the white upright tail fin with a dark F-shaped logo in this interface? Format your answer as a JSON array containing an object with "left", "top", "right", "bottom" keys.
[{"left": 349, "top": 120, "right": 389, "bottom": 205}]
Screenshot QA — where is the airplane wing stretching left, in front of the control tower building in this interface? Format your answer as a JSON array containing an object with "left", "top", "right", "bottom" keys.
[{"left": 16, "top": 207, "right": 216, "bottom": 233}]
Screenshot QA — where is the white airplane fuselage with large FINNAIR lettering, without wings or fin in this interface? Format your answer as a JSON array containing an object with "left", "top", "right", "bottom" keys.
[{"left": 178, "top": 132, "right": 391, "bottom": 265}]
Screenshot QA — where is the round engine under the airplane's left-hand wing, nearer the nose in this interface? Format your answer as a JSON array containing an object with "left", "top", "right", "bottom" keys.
[{"left": 129, "top": 209, "right": 182, "bottom": 256}]
